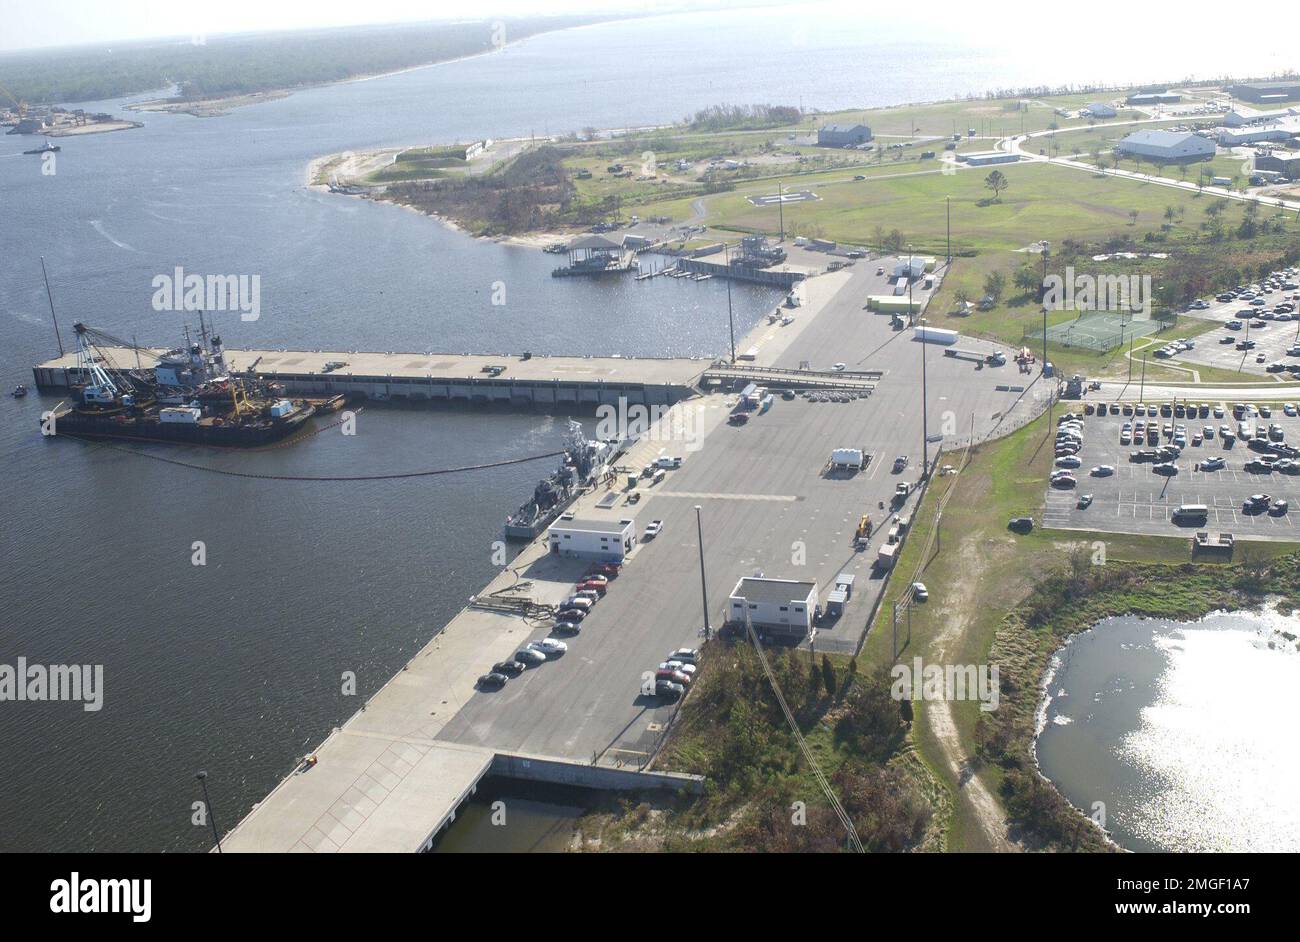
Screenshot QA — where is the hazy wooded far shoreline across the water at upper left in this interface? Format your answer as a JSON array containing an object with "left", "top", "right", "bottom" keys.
[{"left": 0, "top": 16, "right": 614, "bottom": 108}]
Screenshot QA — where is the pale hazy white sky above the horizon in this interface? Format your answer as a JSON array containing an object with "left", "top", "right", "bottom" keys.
[{"left": 0, "top": 0, "right": 1232, "bottom": 54}]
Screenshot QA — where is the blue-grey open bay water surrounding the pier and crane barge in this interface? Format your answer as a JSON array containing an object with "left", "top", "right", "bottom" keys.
[{"left": 0, "top": 5, "right": 1294, "bottom": 850}]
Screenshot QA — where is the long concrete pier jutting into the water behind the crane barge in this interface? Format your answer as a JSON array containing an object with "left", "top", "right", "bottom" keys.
[{"left": 33, "top": 348, "right": 712, "bottom": 409}]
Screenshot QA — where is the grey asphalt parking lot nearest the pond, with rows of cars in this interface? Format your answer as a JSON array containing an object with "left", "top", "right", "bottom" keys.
[{"left": 1043, "top": 404, "right": 1300, "bottom": 541}]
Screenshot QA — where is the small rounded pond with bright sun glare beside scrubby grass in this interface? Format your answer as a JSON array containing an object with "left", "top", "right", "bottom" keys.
[{"left": 1037, "top": 612, "right": 1300, "bottom": 852}]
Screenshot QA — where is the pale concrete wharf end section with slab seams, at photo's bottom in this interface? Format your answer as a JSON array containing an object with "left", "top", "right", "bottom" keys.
[{"left": 222, "top": 729, "right": 495, "bottom": 854}]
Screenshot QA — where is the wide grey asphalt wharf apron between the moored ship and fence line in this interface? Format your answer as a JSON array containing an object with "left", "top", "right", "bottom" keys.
[{"left": 441, "top": 261, "right": 1045, "bottom": 761}]
